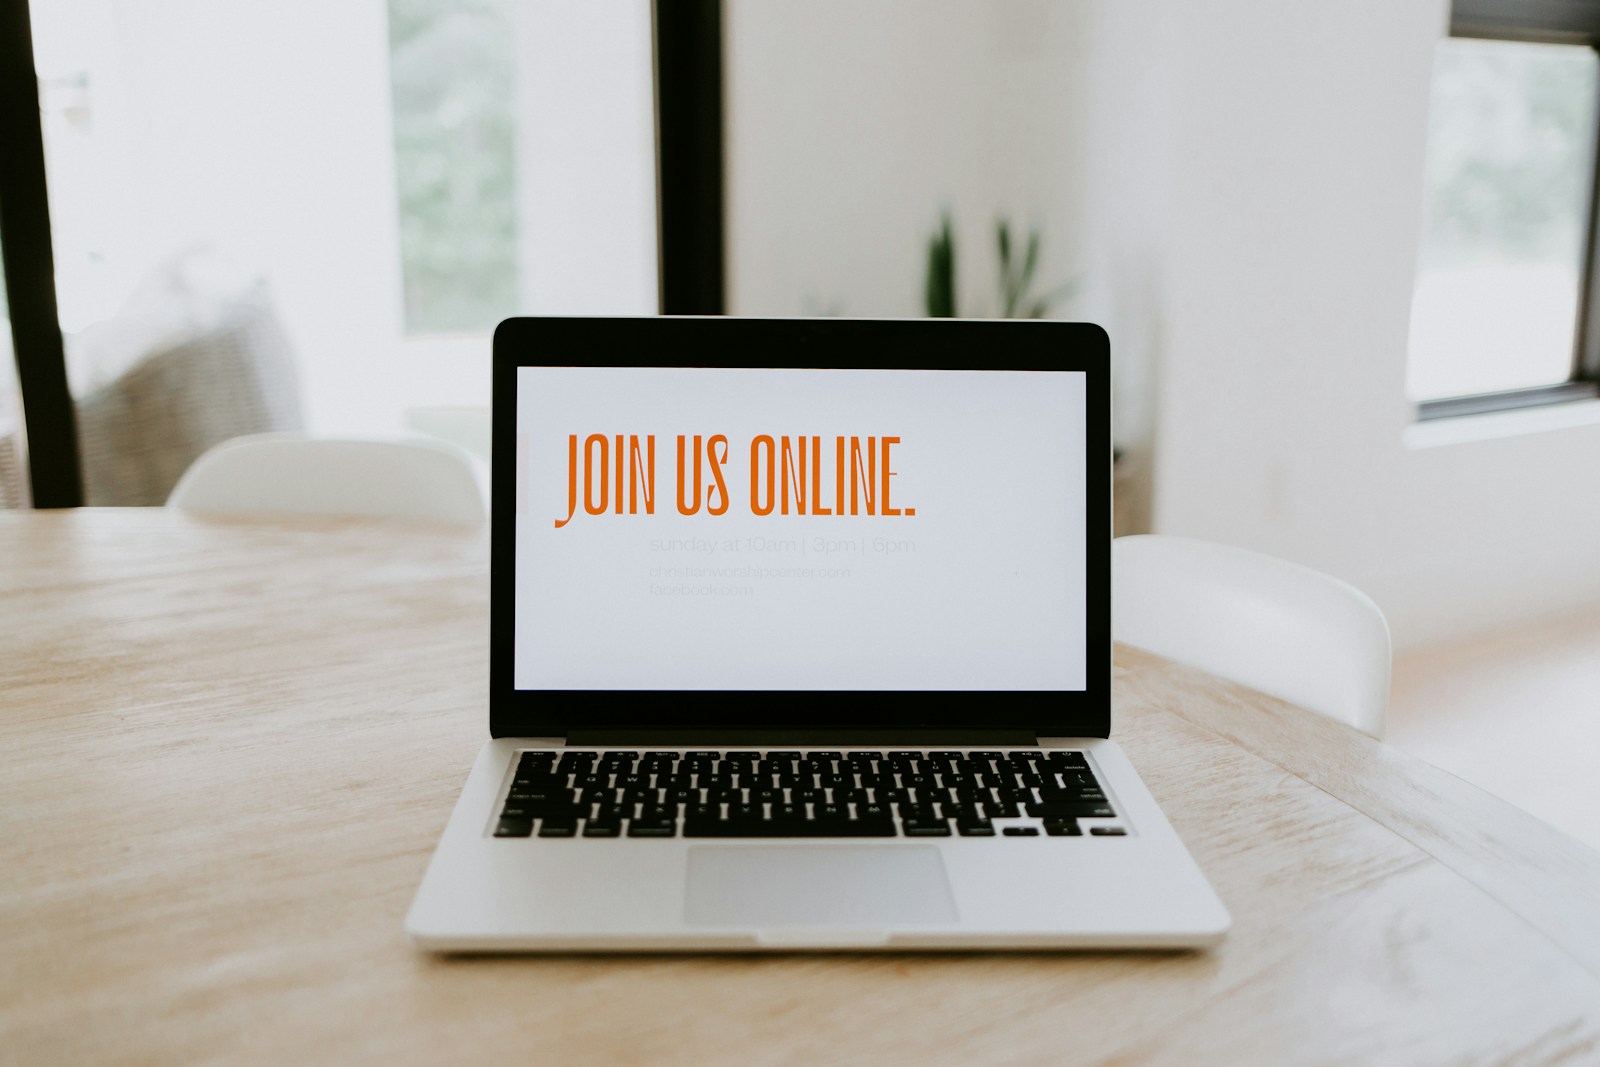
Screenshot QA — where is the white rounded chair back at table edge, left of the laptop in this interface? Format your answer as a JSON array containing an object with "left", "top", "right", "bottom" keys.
[{"left": 166, "top": 434, "right": 485, "bottom": 525}]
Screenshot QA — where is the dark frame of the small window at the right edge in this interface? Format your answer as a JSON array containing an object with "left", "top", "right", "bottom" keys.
[{"left": 1408, "top": 0, "right": 1600, "bottom": 422}]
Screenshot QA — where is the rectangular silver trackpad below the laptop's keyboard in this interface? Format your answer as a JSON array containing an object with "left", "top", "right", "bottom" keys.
[{"left": 683, "top": 845, "right": 957, "bottom": 929}]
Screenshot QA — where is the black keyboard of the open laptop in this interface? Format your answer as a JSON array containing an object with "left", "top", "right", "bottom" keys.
[{"left": 494, "top": 749, "right": 1126, "bottom": 838}]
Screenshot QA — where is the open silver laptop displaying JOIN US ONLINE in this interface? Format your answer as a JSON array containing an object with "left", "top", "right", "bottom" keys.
[{"left": 406, "top": 318, "right": 1229, "bottom": 952}]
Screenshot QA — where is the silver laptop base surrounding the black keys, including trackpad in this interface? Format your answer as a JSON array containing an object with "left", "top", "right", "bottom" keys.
[{"left": 406, "top": 737, "right": 1229, "bottom": 952}]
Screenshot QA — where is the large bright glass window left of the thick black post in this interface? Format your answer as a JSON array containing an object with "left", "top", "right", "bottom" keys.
[{"left": 15, "top": 0, "right": 658, "bottom": 457}]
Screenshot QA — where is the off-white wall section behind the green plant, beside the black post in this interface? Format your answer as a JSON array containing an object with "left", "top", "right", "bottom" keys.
[{"left": 723, "top": 0, "right": 1090, "bottom": 323}]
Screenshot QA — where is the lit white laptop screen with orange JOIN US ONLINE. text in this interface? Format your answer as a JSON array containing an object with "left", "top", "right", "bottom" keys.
[{"left": 512, "top": 365, "right": 1099, "bottom": 693}]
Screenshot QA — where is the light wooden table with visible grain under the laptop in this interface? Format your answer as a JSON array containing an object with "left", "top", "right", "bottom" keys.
[{"left": 0, "top": 510, "right": 1600, "bottom": 1067}]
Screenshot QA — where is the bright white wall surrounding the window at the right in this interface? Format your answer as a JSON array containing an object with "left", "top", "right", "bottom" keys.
[{"left": 1147, "top": 0, "right": 1600, "bottom": 645}]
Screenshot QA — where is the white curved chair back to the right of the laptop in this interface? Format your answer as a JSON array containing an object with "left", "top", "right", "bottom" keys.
[{"left": 1110, "top": 536, "right": 1390, "bottom": 737}]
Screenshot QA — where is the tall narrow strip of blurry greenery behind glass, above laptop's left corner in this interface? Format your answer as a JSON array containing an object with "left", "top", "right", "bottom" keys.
[{"left": 389, "top": 0, "right": 518, "bottom": 334}]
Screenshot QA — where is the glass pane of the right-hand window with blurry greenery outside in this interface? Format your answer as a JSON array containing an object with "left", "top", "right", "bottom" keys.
[{"left": 1406, "top": 38, "right": 1600, "bottom": 402}]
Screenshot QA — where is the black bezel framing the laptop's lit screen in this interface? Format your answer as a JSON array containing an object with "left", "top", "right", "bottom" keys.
[{"left": 490, "top": 317, "right": 1112, "bottom": 737}]
